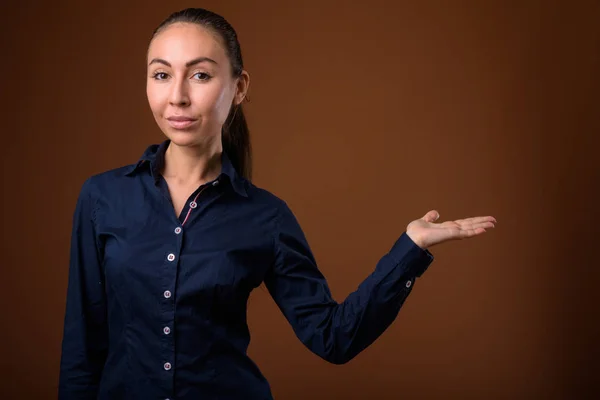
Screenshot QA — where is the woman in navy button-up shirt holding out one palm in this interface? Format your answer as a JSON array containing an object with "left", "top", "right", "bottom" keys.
[{"left": 59, "top": 9, "right": 496, "bottom": 400}]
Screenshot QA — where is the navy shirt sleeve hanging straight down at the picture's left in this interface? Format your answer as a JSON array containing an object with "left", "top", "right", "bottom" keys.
[{"left": 58, "top": 179, "right": 108, "bottom": 400}]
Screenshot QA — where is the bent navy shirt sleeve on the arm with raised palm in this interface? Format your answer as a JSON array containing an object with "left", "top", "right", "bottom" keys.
[{"left": 265, "top": 203, "right": 433, "bottom": 364}]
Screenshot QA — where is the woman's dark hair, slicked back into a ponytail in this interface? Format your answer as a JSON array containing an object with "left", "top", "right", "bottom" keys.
[{"left": 152, "top": 8, "right": 252, "bottom": 180}]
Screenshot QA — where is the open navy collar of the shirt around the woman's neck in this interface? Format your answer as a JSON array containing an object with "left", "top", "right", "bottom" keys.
[{"left": 125, "top": 139, "right": 248, "bottom": 197}]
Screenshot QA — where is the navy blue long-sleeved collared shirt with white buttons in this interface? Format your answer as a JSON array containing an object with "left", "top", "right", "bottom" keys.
[{"left": 59, "top": 141, "right": 433, "bottom": 400}]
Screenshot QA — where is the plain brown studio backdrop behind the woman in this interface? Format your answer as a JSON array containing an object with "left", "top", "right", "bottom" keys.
[{"left": 0, "top": 0, "right": 600, "bottom": 399}]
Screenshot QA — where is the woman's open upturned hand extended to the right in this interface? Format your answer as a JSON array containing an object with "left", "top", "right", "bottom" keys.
[{"left": 406, "top": 210, "right": 496, "bottom": 249}]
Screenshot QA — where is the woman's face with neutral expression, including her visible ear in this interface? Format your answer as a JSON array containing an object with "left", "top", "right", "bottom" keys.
[{"left": 146, "top": 23, "right": 248, "bottom": 146}]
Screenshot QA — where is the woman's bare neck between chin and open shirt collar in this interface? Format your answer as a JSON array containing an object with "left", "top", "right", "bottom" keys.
[{"left": 162, "top": 142, "right": 223, "bottom": 186}]
